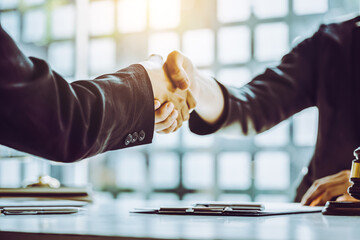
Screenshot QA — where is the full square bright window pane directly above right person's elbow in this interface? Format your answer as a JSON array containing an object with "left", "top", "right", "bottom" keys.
[{"left": 255, "top": 23, "right": 289, "bottom": 61}]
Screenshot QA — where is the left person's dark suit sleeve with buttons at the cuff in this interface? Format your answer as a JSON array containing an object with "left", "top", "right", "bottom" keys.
[{"left": 0, "top": 26, "right": 154, "bottom": 162}]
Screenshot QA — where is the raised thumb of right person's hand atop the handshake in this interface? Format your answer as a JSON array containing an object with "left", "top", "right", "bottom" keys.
[{"left": 165, "top": 51, "right": 190, "bottom": 90}]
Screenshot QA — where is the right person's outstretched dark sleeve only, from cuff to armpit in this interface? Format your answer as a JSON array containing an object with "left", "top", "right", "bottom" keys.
[{"left": 189, "top": 27, "right": 322, "bottom": 135}]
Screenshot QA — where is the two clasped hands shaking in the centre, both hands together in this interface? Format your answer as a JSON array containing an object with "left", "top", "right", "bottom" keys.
[{"left": 140, "top": 51, "right": 224, "bottom": 133}]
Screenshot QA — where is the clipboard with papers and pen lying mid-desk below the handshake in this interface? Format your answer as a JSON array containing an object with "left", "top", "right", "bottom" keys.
[{"left": 130, "top": 202, "right": 323, "bottom": 217}]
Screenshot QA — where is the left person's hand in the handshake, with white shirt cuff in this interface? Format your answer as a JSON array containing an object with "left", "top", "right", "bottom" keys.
[{"left": 140, "top": 55, "right": 196, "bottom": 133}]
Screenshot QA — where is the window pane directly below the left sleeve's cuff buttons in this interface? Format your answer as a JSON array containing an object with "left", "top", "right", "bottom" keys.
[{"left": 116, "top": 152, "right": 146, "bottom": 189}]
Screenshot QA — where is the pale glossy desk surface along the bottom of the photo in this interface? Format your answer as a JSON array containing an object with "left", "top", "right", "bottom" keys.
[{"left": 0, "top": 200, "right": 360, "bottom": 240}]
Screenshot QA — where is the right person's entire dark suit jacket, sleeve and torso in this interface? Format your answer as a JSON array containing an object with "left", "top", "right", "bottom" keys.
[{"left": 190, "top": 17, "right": 360, "bottom": 201}]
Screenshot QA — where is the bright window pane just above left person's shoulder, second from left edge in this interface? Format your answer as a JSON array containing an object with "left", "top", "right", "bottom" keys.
[{"left": 23, "top": 9, "right": 46, "bottom": 42}]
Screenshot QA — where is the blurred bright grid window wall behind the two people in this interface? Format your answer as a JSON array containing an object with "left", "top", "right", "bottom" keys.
[{"left": 0, "top": 0, "right": 360, "bottom": 202}]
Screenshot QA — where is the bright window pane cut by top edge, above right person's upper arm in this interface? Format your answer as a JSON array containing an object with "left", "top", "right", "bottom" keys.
[{"left": 294, "top": 0, "right": 328, "bottom": 15}]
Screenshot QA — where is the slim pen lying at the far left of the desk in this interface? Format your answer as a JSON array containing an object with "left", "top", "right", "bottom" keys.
[{"left": 1, "top": 207, "right": 79, "bottom": 215}]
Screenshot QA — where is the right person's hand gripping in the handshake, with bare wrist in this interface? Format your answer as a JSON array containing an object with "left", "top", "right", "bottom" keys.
[{"left": 156, "top": 51, "right": 224, "bottom": 133}]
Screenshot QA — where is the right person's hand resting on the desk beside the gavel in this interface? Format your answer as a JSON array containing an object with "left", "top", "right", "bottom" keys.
[{"left": 301, "top": 170, "right": 351, "bottom": 206}]
